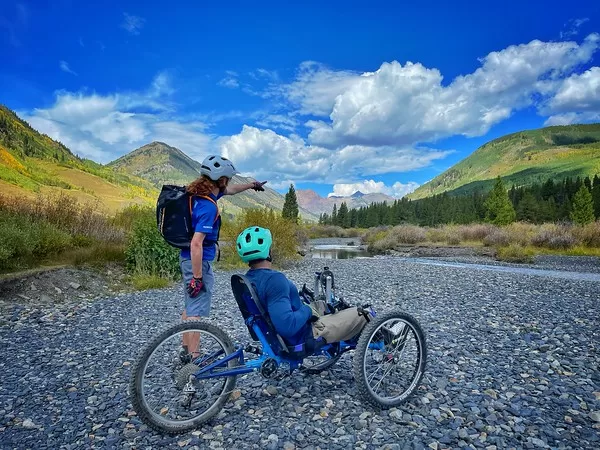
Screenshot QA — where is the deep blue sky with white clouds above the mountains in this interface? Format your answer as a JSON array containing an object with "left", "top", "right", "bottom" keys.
[{"left": 0, "top": 0, "right": 600, "bottom": 197}]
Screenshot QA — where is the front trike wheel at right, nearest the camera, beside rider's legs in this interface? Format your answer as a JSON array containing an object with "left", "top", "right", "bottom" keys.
[{"left": 353, "top": 311, "right": 427, "bottom": 408}]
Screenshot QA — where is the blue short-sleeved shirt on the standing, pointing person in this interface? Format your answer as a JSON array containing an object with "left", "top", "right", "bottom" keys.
[{"left": 181, "top": 192, "right": 223, "bottom": 261}]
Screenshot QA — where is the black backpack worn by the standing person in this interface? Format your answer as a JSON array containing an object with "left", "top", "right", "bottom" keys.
[{"left": 156, "top": 184, "right": 219, "bottom": 250}]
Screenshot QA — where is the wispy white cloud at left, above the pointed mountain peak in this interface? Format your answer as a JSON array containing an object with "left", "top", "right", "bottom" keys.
[{"left": 20, "top": 73, "right": 212, "bottom": 163}]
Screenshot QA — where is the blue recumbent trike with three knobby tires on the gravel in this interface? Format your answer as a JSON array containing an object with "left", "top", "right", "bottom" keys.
[{"left": 129, "top": 267, "right": 427, "bottom": 434}]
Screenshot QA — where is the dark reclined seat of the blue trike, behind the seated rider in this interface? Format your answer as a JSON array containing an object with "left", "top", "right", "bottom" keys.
[{"left": 231, "top": 275, "right": 324, "bottom": 359}]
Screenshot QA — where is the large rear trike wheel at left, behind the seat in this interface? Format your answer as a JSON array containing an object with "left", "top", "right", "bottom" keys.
[{"left": 129, "top": 321, "right": 236, "bottom": 434}]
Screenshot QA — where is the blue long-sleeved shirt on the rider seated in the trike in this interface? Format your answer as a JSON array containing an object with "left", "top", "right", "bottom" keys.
[{"left": 246, "top": 269, "right": 312, "bottom": 345}]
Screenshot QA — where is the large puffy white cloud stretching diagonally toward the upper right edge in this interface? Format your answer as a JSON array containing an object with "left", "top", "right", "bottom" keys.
[{"left": 306, "top": 34, "right": 600, "bottom": 147}]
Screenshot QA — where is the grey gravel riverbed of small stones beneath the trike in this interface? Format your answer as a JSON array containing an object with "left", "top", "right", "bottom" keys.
[{"left": 0, "top": 257, "right": 600, "bottom": 450}]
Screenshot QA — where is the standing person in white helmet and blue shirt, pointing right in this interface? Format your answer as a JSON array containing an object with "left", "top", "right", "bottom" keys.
[{"left": 179, "top": 155, "right": 266, "bottom": 361}]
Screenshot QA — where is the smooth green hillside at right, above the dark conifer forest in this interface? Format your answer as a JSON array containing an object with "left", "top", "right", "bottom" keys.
[{"left": 408, "top": 124, "right": 600, "bottom": 199}]
